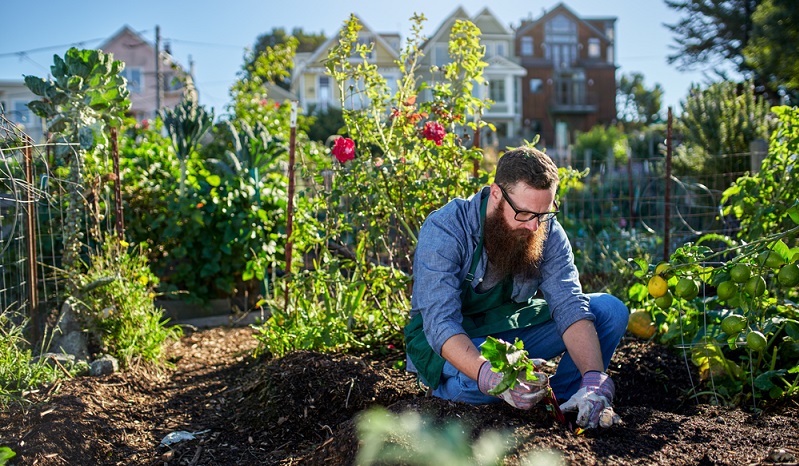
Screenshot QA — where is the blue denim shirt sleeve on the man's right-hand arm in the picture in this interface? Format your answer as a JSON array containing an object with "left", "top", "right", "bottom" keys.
[{"left": 539, "top": 220, "right": 594, "bottom": 335}]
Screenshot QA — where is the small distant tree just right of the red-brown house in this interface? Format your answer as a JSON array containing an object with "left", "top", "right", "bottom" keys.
[{"left": 616, "top": 73, "right": 663, "bottom": 129}]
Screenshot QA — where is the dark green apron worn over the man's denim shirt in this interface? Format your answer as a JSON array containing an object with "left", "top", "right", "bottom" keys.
[{"left": 405, "top": 196, "right": 550, "bottom": 390}]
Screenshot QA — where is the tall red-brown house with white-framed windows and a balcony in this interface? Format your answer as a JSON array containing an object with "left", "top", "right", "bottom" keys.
[{"left": 515, "top": 3, "right": 616, "bottom": 154}]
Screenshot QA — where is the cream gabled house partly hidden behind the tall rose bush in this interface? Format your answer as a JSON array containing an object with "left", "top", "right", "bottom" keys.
[{"left": 291, "top": 15, "right": 400, "bottom": 114}]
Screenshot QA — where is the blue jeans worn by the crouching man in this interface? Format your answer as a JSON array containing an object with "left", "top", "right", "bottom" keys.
[{"left": 433, "top": 293, "right": 630, "bottom": 404}]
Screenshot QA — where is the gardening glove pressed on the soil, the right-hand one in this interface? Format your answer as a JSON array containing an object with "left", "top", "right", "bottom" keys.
[{"left": 560, "top": 371, "right": 621, "bottom": 429}]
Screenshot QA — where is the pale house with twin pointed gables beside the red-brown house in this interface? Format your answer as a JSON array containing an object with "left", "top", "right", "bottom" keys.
[{"left": 421, "top": 7, "right": 526, "bottom": 147}]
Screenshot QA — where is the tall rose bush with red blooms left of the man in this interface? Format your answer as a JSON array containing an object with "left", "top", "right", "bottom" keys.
[{"left": 262, "top": 16, "right": 494, "bottom": 352}]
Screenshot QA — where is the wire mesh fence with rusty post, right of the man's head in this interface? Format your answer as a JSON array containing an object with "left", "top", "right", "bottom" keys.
[{"left": 560, "top": 147, "right": 761, "bottom": 291}]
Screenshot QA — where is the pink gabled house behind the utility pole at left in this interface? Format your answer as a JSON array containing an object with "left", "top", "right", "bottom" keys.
[{"left": 98, "top": 26, "right": 189, "bottom": 121}]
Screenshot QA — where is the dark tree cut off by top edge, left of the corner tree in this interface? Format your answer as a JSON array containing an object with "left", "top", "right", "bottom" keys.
[{"left": 665, "top": 0, "right": 762, "bottom": 76}]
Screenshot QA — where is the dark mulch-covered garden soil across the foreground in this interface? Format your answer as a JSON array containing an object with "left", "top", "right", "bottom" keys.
[{"left": 0, "top": 327, "right": 799, "bottom": 466}]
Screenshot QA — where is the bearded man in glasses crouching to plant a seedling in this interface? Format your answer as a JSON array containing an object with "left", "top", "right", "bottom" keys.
[{"left": 405, "top": 147, "right": 629, "bottom": 428}]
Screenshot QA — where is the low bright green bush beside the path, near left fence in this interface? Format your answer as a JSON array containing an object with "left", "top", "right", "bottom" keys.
[{"left": 75, "top": 236, "right": 183, "bottom": 367}]
